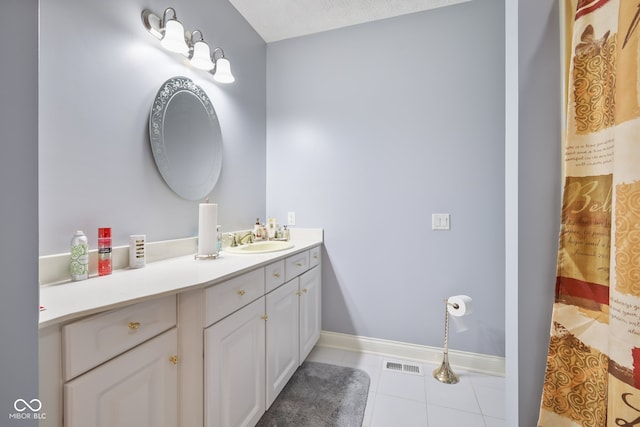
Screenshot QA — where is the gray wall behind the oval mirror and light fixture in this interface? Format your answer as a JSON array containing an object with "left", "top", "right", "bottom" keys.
[{"left": 39, "top": 0, "right": 266, "bottom": 255}]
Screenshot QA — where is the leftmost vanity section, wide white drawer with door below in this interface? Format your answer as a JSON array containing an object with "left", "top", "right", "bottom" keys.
[{"left": 62, "top": 296, "right": 178, "bottom": 427}]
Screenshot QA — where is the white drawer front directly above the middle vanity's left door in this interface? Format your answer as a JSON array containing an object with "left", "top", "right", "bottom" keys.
[{"left": 204, "top": 268, "right": 265, "bottom": 327}]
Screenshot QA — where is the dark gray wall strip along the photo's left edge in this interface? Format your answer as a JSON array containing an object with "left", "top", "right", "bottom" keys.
[{"left": 0, "top": 0, "right": 39, "bottom": 427}]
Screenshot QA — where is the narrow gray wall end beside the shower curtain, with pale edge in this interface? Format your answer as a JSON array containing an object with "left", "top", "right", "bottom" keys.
[{"left": 506, "top": 0, "right": 561, "bottom": 427}]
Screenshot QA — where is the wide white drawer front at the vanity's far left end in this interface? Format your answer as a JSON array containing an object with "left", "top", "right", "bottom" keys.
[{"left": 62, "top": 295, "right": 176, "bottom": 381}]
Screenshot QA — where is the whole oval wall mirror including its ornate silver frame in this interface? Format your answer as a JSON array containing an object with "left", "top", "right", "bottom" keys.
[{"left": 149, "top": 77, "right": 222, "bottom": 200}]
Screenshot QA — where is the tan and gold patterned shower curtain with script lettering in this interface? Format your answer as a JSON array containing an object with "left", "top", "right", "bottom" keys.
[{"left": 538, "top": 0, "right": 640, "bottom": 427}]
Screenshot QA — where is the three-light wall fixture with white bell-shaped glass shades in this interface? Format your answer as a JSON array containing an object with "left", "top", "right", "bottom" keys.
[{"left": 142, "top": 7, "right": 235, "bottom": 83}]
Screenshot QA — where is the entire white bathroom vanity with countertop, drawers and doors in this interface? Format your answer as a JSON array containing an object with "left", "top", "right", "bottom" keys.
[{"left": 40, "top": 230, "right": 322, "bottom": 427}]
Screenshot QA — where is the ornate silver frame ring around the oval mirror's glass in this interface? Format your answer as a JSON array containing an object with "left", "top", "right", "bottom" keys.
[{"left": 149, "top": 76, "right": 222, "bottom": 200}]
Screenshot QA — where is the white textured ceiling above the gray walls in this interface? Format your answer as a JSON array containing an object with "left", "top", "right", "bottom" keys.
[{"left": 229, "top": 0, "right": 470, "bottom": 43}]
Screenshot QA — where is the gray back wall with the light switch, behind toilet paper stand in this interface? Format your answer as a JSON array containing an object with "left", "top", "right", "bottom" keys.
[{"left": 267, "top": 0, "right": 505, "bottom": 356}]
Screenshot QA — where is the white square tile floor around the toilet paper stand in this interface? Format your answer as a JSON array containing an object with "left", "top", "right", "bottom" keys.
[{"left": 307, "top": 347, "right": 505, "bottom": 427}]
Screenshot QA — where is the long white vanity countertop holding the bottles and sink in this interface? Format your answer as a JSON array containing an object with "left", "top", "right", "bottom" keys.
[{"left": 39, "top": 231, "right": 322, "bottom": 328}]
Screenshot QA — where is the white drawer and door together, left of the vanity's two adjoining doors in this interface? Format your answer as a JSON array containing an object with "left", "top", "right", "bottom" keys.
[{"left": 204, "top": 268, "right": 265, "bottom": 427}]
